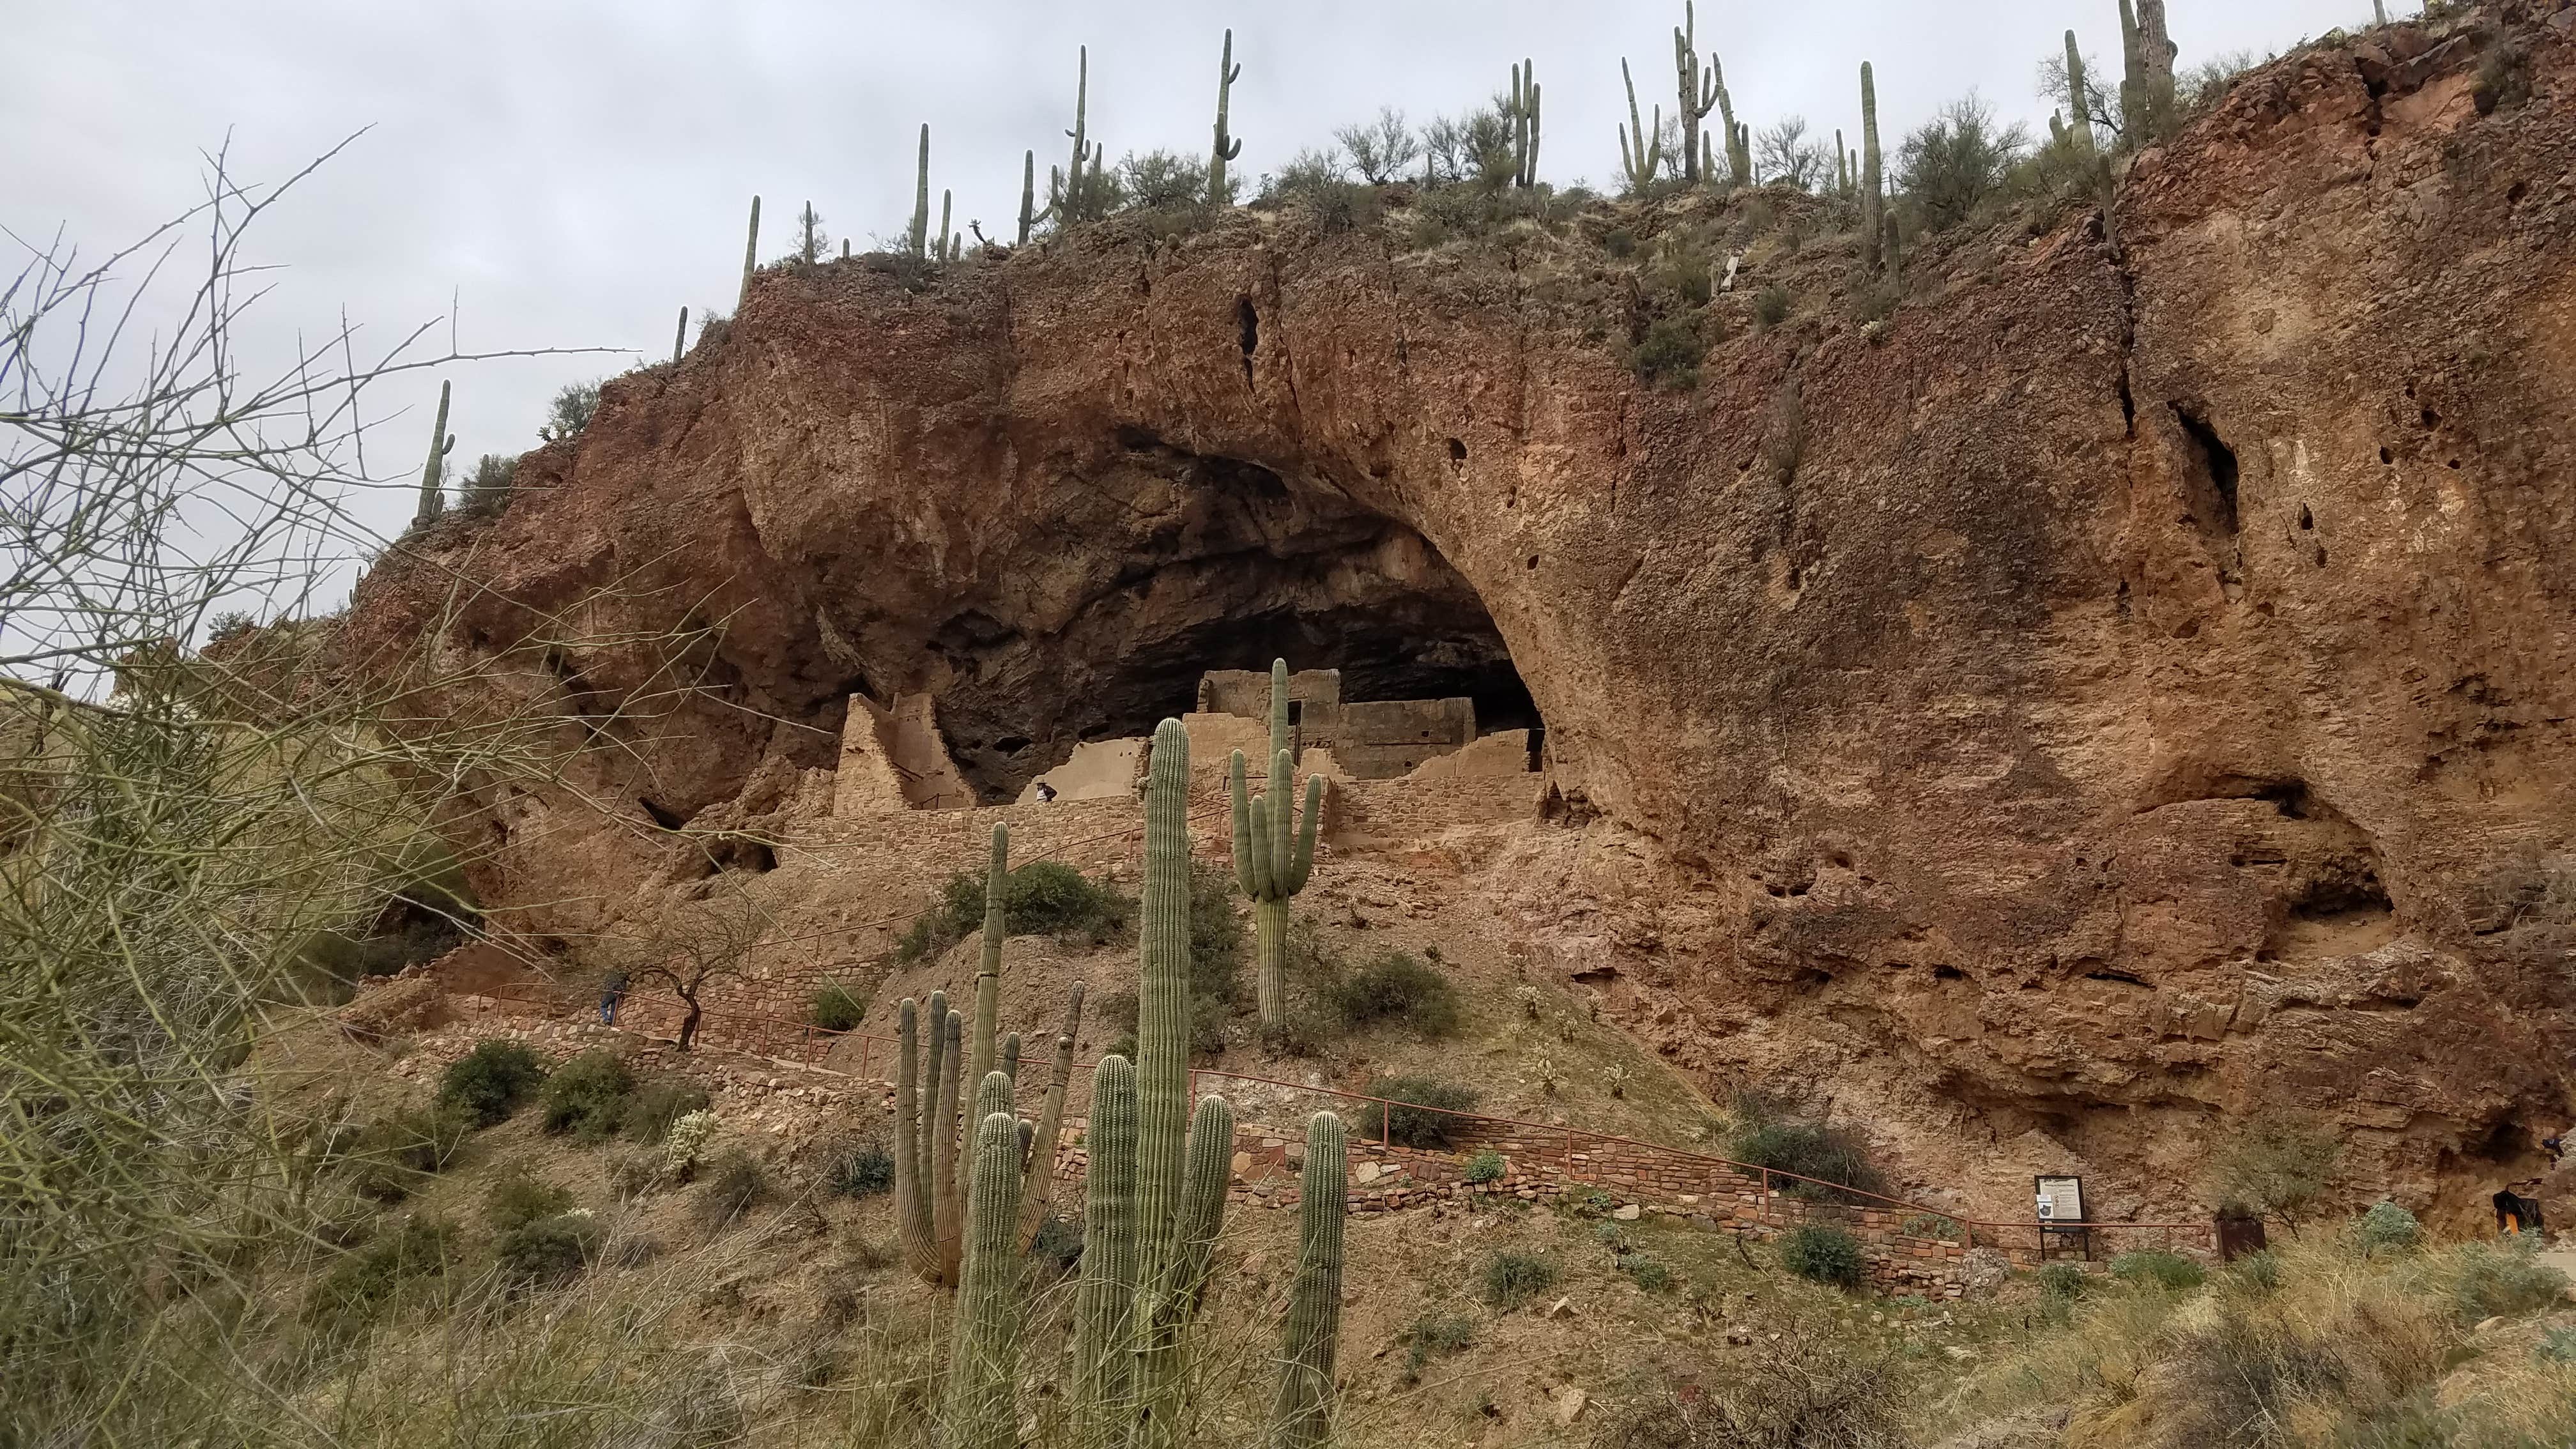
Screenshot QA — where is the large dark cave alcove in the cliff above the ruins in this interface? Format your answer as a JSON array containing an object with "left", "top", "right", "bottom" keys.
[{"left": 922, "top": 431, "right": 1540, "bottom": 804}]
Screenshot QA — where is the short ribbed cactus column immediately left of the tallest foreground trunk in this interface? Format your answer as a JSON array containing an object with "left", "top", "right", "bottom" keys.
[{"left": 1074, "top": 1057, "right": 1138, "bottom": 1446}]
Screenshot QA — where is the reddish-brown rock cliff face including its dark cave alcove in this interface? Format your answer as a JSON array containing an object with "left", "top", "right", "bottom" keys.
[{"left": 350, "top": 5, "right": 2576, "bottom": 1191}]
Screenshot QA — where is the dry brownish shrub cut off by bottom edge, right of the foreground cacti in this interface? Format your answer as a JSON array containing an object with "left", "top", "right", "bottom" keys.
[{"left": 1592, "top": 1328, "right": 1909, "bottom": 1449}]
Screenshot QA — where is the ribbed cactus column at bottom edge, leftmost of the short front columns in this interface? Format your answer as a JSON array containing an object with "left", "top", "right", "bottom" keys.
[{"left": 940, "top": 1093, "right": 1023, "bottom": 1449}]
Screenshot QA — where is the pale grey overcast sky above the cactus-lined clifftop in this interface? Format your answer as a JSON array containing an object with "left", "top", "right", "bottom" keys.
[{"left": 0, "top": 0, "right": 2380, "bottom": 564}]
